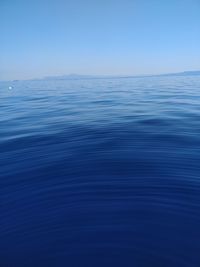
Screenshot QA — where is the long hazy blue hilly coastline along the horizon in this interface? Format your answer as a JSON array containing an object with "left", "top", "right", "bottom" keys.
[{"left": 43, "top": 70, "right": 200, "bottom": 80}]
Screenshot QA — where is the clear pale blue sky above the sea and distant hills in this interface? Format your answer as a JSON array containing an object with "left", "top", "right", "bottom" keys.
[{"left": 0, "top": 0, "right": 200, "bottom": 80}]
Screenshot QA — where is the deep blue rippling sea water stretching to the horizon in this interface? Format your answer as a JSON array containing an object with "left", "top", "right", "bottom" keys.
[{"left": 0, "top": 76, "right": 200, "bottom": 267}]
